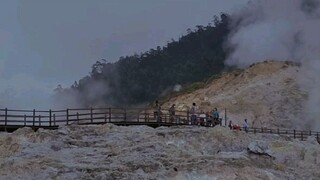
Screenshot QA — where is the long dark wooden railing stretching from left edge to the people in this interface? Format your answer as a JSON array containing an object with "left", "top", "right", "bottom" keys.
[{"left": 0, "top": 108, "right": 190, "bottom": 127}]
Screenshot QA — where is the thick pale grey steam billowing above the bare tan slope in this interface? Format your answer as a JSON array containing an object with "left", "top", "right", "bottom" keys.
[{"left": 226, "top": 0, "right": 320, "bottom": 129}]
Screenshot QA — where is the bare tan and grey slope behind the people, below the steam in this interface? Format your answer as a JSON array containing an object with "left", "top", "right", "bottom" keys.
[{"left": 163, "top": 61, "right": 308, "bottom": 129}]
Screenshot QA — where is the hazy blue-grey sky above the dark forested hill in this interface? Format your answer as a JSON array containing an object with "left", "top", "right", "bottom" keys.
[{"left": 0, "top": 0, "right": 248, "bottom": 108}]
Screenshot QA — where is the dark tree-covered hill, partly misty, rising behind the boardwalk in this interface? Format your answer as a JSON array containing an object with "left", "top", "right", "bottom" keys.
[{"left": 56, "top": 14, "right": 229, "bottom": 106}]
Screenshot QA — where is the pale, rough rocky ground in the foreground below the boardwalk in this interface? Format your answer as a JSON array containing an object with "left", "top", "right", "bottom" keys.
[{"left": 0, "top": 124, "right": 320, "bottom": 179}]
